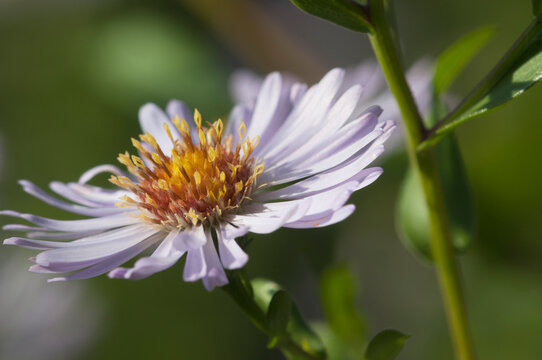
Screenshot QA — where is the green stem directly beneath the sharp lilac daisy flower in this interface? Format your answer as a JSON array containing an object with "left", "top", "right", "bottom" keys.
[{"left": 222, "top": 270, "right": 321, "bottom": 360}]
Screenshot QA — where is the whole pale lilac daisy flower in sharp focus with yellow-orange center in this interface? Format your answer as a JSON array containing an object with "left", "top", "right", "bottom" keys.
[{"left": 1, "top": 69, "right": 394, "bottom": 290}]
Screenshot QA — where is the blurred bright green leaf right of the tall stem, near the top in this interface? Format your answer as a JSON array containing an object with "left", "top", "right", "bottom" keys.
[{"left": 433, "top": 27, "right": 493, "bottom": 95}]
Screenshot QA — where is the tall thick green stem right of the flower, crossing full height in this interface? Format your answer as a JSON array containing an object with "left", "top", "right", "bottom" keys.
[{"left": 369, "top": 0, "right": 474, "bottom": 360}]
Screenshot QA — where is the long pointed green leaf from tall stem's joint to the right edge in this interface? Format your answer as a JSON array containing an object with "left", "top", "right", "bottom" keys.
[{"left": 428, "top": 17, "right": 542, "bottom": 151}]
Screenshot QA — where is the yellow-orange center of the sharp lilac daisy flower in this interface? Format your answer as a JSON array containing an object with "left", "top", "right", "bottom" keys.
[{"left": 110, "top": 110, "right": 263, "bottom": 229}]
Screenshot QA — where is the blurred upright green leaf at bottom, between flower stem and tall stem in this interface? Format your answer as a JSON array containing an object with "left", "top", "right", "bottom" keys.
[{"left": 320, "top": 265, "right": 365, "bottom": 354}]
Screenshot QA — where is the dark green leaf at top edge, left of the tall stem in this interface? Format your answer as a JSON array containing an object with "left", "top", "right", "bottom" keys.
[{"left": 291, "top": 0, "right": 373, "bottom": 33}]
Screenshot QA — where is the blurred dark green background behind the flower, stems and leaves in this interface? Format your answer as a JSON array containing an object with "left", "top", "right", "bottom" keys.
[{"left": 0, "top": 0, "right": 542, "bottom": 360}]
